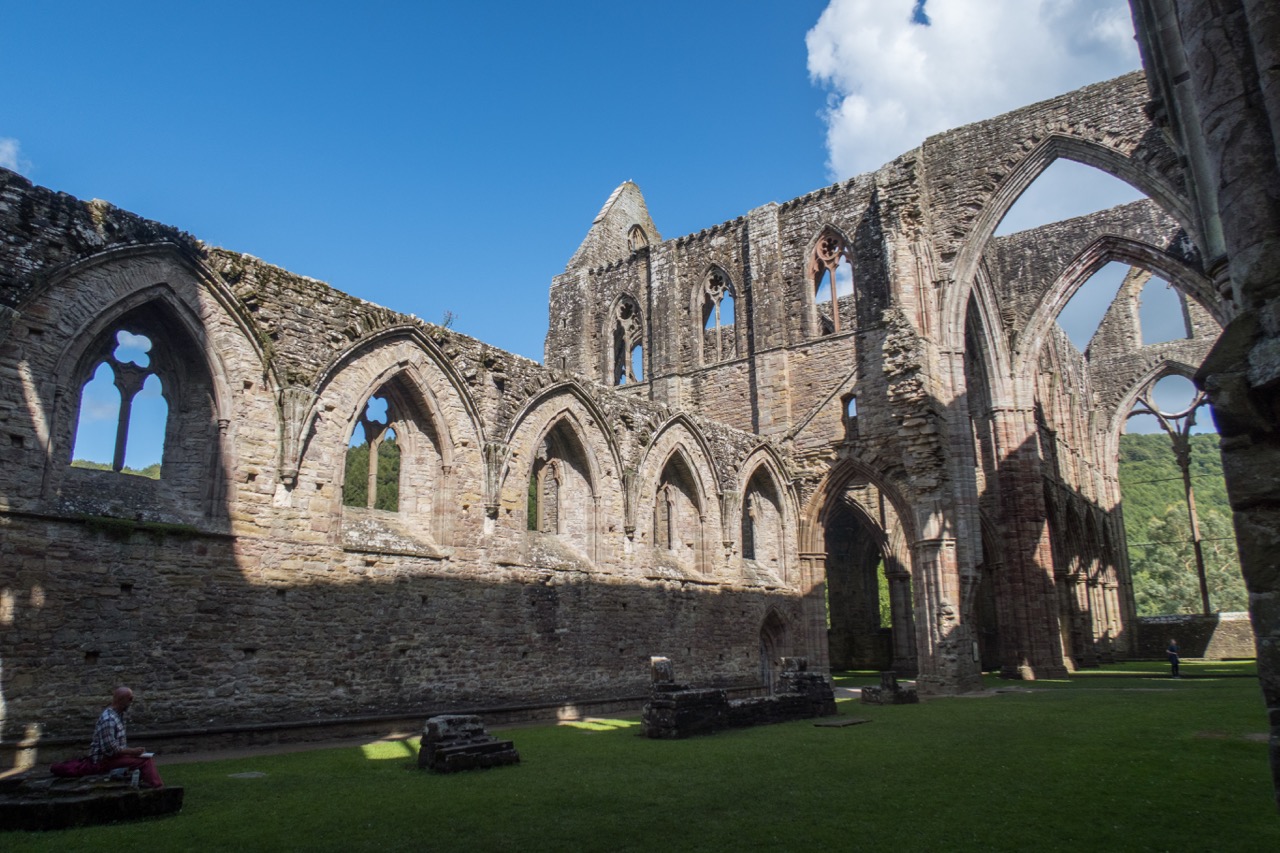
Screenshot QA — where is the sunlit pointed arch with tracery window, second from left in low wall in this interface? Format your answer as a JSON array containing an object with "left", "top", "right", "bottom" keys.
[{"left": 299, "top": 327, "right": 484, "bottom": 557}]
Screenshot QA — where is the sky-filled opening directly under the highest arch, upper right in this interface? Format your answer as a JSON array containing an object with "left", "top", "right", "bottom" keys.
[{"left": 996, "top": 158, "right": 1146, "bottom": 237}]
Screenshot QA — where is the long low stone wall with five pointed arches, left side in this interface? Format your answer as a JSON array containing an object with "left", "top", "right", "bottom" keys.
[{"left": 0, "top": 173, "right": 799, "bottom": 742}]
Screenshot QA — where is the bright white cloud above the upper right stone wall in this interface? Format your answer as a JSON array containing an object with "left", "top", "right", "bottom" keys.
[{"left": 805, "top": 0, "right": 1139, "bottom": 179}]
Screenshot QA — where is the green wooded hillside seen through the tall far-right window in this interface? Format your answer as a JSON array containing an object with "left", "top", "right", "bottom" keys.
[{"left": 1120, "top": 434, "right": 1248, "bottom": 616}]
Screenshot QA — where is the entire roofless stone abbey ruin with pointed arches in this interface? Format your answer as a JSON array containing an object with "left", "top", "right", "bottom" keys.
[{"left": 0, "top": 0, "right": 1280, "bottom": 799}]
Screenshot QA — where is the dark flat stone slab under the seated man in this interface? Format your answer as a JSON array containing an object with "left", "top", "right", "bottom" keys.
[{"left": 0, "top": 776, "right": 183, "bottom": 830}]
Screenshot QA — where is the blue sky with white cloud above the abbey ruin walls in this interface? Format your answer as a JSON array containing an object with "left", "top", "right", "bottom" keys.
[{"left": 10, "top": 0, "right": 1187, "bottom": 458}]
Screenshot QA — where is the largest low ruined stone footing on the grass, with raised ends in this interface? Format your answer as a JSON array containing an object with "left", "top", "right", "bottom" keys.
[{"left": 641, "top": 657, "right": 836, "bottom": 739}]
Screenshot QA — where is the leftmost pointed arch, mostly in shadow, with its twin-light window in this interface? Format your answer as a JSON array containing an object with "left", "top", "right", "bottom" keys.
[{"left": 40, "top": 253, "right": 244, "bottom": 525}]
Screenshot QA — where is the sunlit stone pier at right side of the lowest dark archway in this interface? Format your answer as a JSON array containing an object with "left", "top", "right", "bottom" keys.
[{"left": 911, "top": 538, "right": 982, "bottom": 694}]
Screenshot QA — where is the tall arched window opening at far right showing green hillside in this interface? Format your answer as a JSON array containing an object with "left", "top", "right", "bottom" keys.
[{"left": 1120, "top": 375, "right": 1248, "bottom": 616}]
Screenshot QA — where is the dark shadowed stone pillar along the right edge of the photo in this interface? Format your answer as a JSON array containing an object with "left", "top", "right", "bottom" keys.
[{"left": 1130, "top": 0, "right": 1280, "bottom": 807}]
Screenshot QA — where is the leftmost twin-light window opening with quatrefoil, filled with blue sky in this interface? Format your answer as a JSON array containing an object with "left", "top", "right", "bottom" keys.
[{"left": 72, "top": 329, "right": 169, "bottom": 479}]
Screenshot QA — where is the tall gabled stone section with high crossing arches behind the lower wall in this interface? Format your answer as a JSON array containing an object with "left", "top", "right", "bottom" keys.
[{"left": 547, "top": 68, "right": 1228, "bottom": 692}]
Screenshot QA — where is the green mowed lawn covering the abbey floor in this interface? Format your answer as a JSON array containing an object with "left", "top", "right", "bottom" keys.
[{"left": 10, "top": 663, "right": 1280, "bottom": 853}]
